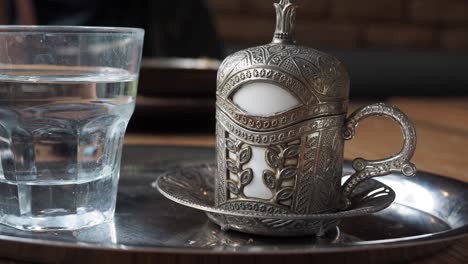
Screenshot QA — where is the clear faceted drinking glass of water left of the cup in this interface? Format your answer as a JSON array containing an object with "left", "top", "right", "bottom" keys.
[{"left": 0, "top": 26, "right": 144, "bottom": 230}]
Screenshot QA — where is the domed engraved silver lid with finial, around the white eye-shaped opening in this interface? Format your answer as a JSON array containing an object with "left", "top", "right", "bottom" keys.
[{"left": 217, "top": 0, "right": 349, "bottom": 121}]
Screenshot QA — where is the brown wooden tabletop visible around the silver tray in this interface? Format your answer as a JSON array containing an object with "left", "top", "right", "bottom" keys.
[{"left": 0, "top": 98, "right": 468, "bottom": 264}]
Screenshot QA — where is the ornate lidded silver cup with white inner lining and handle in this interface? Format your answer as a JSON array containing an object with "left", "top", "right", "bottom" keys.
[{"left": 215, "top": 0, "right": 416, "bottom": 221}]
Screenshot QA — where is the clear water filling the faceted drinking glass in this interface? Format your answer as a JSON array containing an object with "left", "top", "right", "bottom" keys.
[{"left": 0, "top": 65, "right": 137, "bottom": 230}]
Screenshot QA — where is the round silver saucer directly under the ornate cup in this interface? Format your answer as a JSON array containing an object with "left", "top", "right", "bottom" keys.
[{"left": 156, "top": 164, "right": 395, "bottom": 236}]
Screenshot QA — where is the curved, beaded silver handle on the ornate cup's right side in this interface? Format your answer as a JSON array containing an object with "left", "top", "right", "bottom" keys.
[{"left": 342, "top": 104, "right": 416, "bottom": 208}]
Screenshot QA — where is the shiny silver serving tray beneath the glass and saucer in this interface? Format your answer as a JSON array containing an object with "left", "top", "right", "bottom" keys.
[{"left": 0, "top": 146, "right": 468, "bottom": 263}]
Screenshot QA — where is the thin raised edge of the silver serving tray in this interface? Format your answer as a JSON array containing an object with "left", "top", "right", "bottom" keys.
[{"left": 0, "top": 144, "right": 468, "bottom": 259}]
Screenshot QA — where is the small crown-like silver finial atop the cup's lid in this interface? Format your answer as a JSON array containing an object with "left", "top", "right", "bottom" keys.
[{"left": 273, "top": 0, "right": 299, "bottom": 43}]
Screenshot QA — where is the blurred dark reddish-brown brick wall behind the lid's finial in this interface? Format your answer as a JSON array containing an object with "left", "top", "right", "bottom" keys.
[{"left": 208, "top": 0, "right": 468, "bottom": 50}]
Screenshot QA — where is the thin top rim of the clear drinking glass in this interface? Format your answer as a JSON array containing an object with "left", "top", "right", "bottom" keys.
[{"left": 0, "top": 25, "right": 145, "bottom": 36}]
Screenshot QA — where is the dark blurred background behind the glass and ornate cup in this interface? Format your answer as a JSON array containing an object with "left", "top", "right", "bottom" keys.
[{"left": 0, "top": 0, "right": 468, "bottom": 132}]
